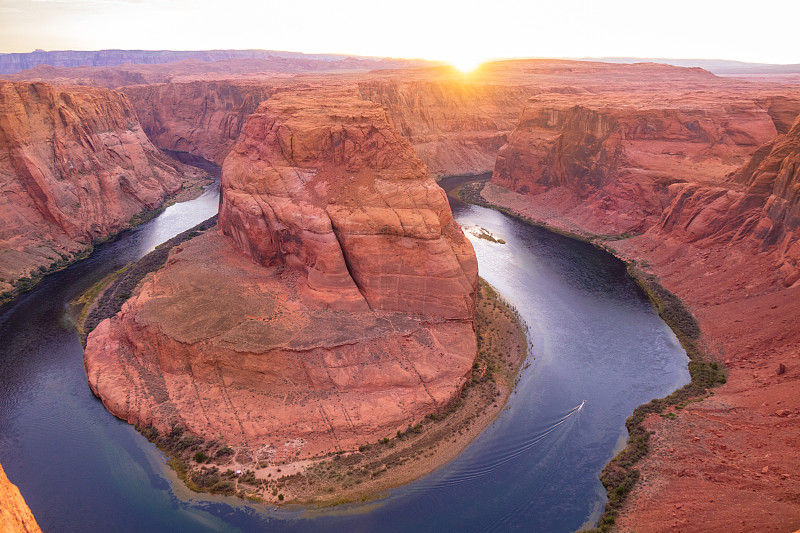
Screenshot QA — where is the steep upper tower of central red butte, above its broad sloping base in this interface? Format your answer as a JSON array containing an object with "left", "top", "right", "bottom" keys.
[{"left": 220, "top": 93, "right": 477, "bottom": 318}]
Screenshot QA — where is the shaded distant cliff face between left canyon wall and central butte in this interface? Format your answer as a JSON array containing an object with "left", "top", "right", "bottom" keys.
[{"left": 122, "top": 81, "right": 273, "bottom": 165}]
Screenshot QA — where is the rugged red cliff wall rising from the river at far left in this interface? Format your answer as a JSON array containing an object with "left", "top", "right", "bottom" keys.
[{"left": 0, "top": 81, "right": 196, "bottom": 292}]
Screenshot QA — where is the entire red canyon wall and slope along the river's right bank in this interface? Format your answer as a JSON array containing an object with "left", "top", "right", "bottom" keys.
[{"left": 482, "top": 91, "right": 800, "bottom": 532}]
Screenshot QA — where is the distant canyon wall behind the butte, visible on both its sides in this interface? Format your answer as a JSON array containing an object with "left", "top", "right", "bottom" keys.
[{"left": 121, "top": 78, "right": 536, "bottom": 176}]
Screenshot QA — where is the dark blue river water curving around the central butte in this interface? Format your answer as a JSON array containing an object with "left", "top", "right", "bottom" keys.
[{"left": 0, "top": 168, "right": 689, "bottom": 532}]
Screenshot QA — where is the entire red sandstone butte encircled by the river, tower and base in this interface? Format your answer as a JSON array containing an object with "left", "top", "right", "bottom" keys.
[{"left": 85, "top": 92, "right": 477, "bottom": 457}]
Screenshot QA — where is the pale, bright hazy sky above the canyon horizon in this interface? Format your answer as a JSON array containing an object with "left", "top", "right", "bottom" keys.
[{"left": 0, "top": 0, "right": 800, "bottom": 63}]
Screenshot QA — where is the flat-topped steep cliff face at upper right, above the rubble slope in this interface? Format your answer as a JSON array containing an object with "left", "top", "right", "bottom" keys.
[{"left": 492, "top": 94, "right": 777, "bottom": 233}]
